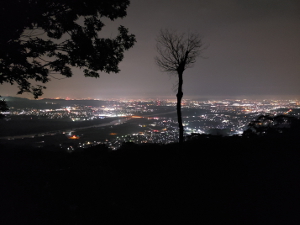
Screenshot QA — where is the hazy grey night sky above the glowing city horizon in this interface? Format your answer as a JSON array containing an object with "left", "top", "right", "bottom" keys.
[{"left": 1, "top": 0, "right": 300, "bottom": 99}]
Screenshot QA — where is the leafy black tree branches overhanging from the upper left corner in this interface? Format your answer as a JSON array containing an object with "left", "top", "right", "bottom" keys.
[{"left": 0, "top": 0, "right": 136, "bottom": 98}]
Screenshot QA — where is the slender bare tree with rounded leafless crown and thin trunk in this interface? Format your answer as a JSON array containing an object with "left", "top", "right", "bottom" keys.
[{"left": 155, "top": 29, "right": 203, "bottom": 144}]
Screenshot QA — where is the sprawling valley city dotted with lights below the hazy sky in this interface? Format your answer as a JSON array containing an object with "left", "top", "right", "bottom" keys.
[{"left": 1, "top": 99, "right": 300, "bottom": 151}]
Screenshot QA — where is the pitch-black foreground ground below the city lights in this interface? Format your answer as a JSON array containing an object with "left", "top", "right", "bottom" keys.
[{"left": 0, "top": 134, "right": 300, "bottom": 225}]
